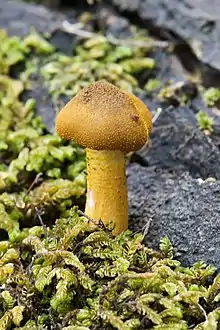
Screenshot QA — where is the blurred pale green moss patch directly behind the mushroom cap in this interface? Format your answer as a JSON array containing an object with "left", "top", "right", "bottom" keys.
[{"left": 23, "top": 30, "right": 155, "bottom": 101}]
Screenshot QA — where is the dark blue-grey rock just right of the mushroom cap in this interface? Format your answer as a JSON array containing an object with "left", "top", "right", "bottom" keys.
[{"left": 138, "top": 107, "right": 220, "bottom": 179}]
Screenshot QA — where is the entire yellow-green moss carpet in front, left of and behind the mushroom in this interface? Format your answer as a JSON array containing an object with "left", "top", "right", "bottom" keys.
[{"left": 0, "top": 14, "right": 220, "bottom": 330}]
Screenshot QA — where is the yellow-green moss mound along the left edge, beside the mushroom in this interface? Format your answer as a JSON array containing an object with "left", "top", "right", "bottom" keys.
[{"left": 0, "top": 31, "right": 86, "bottom": 241}]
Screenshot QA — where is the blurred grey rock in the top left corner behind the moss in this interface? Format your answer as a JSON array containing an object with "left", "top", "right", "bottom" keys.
[{"left": 0, "top": 0, "right": 76, "bottom": 55}]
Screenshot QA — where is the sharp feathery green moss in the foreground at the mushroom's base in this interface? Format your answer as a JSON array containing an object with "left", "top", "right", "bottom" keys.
[{"left": 0, "top": 208, "right": 220, "bottom": 330}]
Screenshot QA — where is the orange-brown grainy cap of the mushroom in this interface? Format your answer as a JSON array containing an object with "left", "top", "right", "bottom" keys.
[{"left": 56, "top": 80, "right": 152, "bottom": 152}]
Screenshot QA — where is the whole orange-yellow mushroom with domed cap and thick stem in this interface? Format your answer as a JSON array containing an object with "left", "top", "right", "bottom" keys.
[{"left": 56, "top": 80, "right": 152, "bottom": 235}]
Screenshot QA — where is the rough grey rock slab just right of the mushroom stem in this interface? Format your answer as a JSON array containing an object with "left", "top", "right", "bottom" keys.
[{"left": 128, "top": 165, "right": 220, "bottom": 269}]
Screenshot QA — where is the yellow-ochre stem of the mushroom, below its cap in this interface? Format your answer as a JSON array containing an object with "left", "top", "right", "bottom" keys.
[{"left": 85, "top": 148, "right": 128, "bottom": 235}]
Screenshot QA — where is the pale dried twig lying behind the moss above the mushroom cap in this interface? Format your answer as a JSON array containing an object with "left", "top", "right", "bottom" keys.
[{"left": 62, "top": 20, "right": 171, "bottom": 48}]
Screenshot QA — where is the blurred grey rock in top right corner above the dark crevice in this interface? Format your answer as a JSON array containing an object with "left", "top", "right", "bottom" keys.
[{"left": 111, "top": 0, "right": 220, "bottom": 74}]
